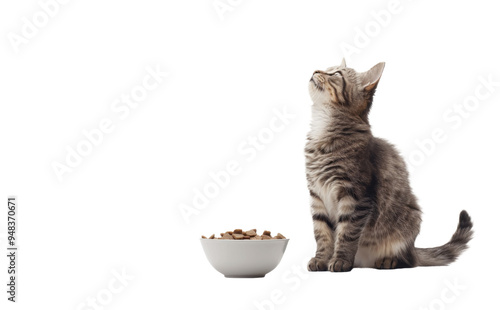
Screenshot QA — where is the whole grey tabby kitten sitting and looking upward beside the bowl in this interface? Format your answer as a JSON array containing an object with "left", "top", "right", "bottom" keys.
[{"left": 305, "top": 60, "right": 472, "bottom": 272}]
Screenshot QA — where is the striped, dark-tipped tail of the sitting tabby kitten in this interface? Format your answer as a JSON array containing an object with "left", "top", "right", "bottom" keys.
[{"left": 415, "top": 210, "right": 473, "bottom": 266}]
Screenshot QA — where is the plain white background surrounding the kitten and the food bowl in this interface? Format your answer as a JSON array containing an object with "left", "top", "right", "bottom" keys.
[{"left": 0, "top": 0, "right": 500, "bottom": 309}]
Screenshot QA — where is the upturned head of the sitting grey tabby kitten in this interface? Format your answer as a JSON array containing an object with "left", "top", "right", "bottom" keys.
[{"left": 309, "top": 59, "right": 385, "bottom": 123}]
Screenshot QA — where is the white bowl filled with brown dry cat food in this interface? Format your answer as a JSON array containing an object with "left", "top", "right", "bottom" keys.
[{"left": 200, "top": 229, "right": 289, "bottom": 278}]
